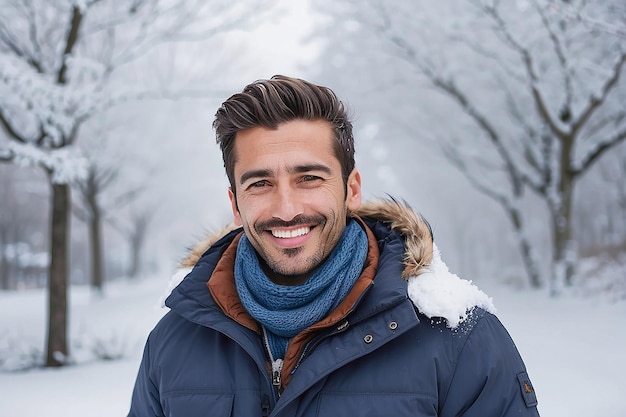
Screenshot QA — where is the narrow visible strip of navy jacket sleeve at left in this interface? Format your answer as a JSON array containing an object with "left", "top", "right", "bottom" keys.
[{"left": 128, "top": 337, "right": 165, "bottom": 417}]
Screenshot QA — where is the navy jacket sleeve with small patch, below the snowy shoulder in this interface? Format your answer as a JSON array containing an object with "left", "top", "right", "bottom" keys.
[{"left": 440, "top": 313, "right": 539, "bottom": 417}]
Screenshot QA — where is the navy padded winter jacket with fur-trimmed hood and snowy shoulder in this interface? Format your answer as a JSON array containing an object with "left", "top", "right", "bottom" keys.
[{"left": 129, "top": 201, "right": 539, "bottom": 417}]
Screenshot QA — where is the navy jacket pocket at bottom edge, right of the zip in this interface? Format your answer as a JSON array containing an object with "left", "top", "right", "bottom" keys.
[{"left": 316, "top": 392, "right": 437, "bottom": 417}]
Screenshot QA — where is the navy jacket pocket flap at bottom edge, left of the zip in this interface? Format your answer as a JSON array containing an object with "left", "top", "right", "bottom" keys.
[{"left": 163, "top": 391, "right": 234, "bottom": 417}]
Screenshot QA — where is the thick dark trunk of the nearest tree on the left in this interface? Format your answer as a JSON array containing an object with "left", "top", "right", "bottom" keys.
[{"left": 46, "top": 183, "right": 70, "bottom": 367}]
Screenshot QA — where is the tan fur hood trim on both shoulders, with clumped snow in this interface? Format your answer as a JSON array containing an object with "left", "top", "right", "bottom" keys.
[{"left": 167, "top": 199, "right": 495, "bottom": 328}]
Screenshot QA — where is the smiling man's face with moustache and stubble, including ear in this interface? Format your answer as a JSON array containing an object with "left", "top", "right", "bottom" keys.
[{"left": 228, "top": 120, "right": 361, "bottom": 285}]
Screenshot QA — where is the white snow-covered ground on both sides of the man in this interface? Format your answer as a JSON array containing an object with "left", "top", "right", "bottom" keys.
[{"left": 0, "top": 272, "right": 626, "bottom": 417}]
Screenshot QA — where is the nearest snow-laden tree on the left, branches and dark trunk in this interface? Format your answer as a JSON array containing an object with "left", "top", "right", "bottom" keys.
[{"left": 0, "top": 0, "right": 267, "bottom": 366}]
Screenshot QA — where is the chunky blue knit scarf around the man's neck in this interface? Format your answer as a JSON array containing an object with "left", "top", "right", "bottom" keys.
[{"left": 235, "top": 220, "right": 368, "bottom": 360}]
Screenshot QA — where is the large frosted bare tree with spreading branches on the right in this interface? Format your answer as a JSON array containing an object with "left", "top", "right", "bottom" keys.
[{"left": 316, "top": 0, "right": 626, "bottom": 294}]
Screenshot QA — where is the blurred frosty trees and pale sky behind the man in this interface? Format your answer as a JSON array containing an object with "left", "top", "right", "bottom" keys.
[{"left": 0, "top": 0, "right": 626, "bottom": 408}]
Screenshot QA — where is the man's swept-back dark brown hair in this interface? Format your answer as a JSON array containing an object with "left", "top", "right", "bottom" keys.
[{"left": 213, "top": 75, "right": 354, "bottom": 192}]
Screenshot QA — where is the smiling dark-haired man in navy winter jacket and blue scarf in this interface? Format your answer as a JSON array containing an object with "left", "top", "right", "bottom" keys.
[{"left": 129, "top": 76, "right": 539, "bottom": 417}]
